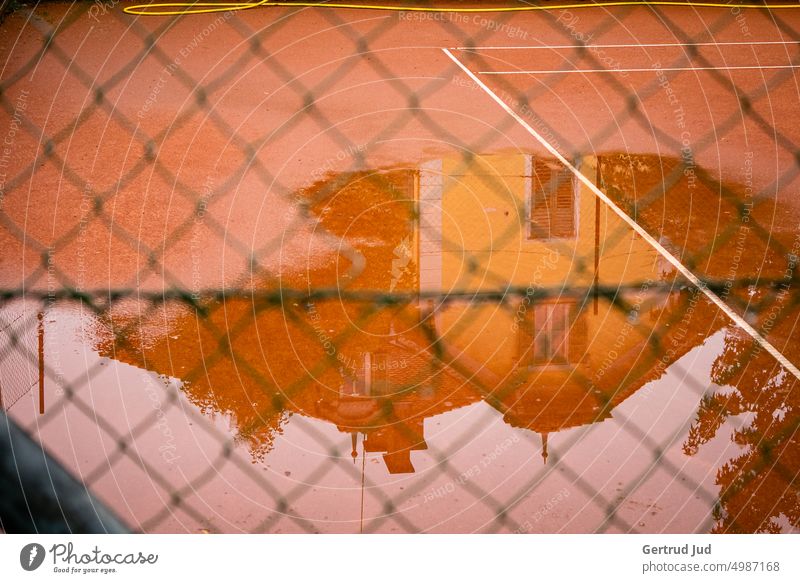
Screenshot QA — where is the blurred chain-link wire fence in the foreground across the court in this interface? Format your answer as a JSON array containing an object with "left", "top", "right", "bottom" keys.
[{"left": 0, "top": 1, "right": 800, "bottom": 532}]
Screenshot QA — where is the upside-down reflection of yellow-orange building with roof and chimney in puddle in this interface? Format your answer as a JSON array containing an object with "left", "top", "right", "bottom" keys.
[{"left": 90, "top": 153, "right": 723, "bottom": 473}]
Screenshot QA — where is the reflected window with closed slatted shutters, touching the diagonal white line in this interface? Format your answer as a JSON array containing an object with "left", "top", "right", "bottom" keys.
[{"left": 526, "top": 157, "right": 578, "bottom": 240}]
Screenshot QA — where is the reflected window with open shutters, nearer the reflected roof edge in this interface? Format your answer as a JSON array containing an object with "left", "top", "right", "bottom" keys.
[{"left": 519, "top": 302, "right": 573, "bottom": 366}]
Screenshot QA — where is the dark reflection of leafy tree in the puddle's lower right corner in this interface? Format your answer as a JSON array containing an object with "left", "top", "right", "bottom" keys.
[{"left": 683, "top": 322, "right": 800, "bottom": 533}]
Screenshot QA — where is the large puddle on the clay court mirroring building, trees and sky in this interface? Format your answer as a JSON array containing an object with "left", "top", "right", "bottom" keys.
[{"left": 0, "top": 153, "right": 798, "bottom": 532}]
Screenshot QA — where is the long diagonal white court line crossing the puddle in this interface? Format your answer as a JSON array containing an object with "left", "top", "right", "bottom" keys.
[{"left": 442, "top": 49, "right": 800, "bottom": 380}]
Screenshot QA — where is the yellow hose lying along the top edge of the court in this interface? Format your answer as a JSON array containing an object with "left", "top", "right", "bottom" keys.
[{"left": 123, "top": 0, "right": 800, "bottom": 16}]
